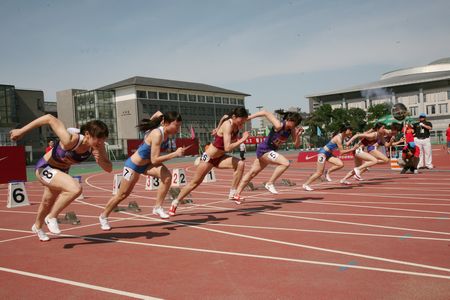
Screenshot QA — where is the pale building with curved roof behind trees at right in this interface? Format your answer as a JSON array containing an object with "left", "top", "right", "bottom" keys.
[{"left": 306, "top": 58, "right": 450, "bottom": 143}]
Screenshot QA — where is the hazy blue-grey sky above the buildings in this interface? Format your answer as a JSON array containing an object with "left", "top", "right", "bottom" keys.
[{"left": 0, "top": 0, "right": 450, "bottom": 112}]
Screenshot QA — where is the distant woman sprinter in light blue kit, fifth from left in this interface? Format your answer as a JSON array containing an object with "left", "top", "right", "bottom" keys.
[{"left": 303, "top": 125, "right": 357, "bottom": 191}]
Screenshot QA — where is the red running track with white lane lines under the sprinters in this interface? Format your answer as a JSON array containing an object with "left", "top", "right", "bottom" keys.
[{"left": 0, "top": 146, "right": 450, "bottom": 299}]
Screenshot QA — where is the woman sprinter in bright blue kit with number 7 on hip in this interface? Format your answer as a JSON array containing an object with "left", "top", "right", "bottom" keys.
[{"left": 99, "top": 111, "right": 186, "bottom": 230}]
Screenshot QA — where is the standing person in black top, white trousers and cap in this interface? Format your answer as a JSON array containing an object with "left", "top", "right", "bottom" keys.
[{"left": 414, "top": 113, "right": 433, "bottom": 169}]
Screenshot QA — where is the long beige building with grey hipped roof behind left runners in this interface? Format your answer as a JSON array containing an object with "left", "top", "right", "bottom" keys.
[{"left": 57, "top": 76, "right": 250, "bottom": 145}]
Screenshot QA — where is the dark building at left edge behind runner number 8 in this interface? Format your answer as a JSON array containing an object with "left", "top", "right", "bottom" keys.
[{"left": 0, "top": 84, "right": 49, "bottom": 161}]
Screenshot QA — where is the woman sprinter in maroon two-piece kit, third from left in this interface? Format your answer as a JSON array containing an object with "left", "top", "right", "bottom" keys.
[{"left": 169, "top": 107, "right": 256, "bottom": 216}]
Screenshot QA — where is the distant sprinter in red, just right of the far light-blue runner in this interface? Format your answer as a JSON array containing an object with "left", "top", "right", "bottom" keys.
[{"left": 347, "top": 122, "right": 389, "bottom": 180}]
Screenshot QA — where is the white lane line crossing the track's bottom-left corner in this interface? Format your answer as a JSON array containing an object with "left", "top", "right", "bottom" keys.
[{"left": 0, "top": 267, "right": 160, "bottom": 300}]
